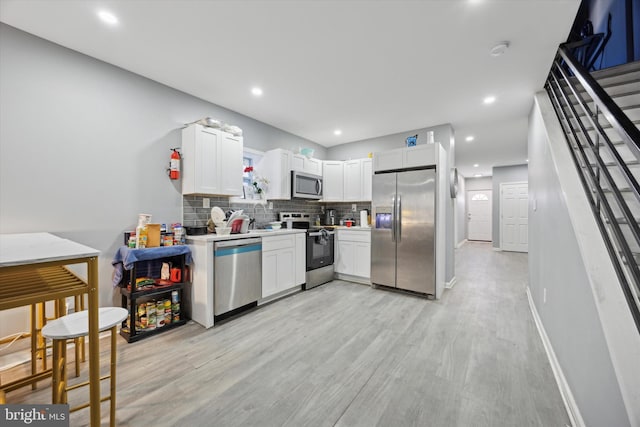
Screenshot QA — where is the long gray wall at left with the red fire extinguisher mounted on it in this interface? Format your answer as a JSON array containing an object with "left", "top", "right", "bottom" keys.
[{"left": 0, "top": 24, "right": 326, "bottom": 318}]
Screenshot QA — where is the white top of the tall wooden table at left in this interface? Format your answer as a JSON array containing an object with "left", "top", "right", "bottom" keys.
[{"left": 0, "top": 233, "right": 100, "bottom": 267}]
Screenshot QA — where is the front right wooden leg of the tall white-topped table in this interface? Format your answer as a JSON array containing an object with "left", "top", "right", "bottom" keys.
[{"left": 87, "top": 257, "right": 100, "bottom": 427}]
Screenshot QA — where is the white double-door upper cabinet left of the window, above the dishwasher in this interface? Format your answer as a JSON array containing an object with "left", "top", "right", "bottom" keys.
[{"left": 181, "top": 124, "right": 243, "bottom": 196}]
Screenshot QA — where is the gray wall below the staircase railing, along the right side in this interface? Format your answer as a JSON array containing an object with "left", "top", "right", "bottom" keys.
[{"left": 528, "top": 98, "right": 629, "bottom": 426}]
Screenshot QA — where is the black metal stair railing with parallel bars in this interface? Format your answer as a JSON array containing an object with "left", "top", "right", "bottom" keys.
[{"left": 545, "top": 45, "right": 640, "bottom": 332}]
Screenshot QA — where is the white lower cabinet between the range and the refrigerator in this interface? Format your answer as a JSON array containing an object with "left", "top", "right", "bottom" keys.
[{"left": 334, "top": 230, "right": 371, "bottom": 280}]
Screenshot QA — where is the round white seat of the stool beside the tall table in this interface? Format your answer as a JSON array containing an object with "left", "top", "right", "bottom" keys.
[{"left": 42, "top": 307, "right": 129, "bottom": 340}]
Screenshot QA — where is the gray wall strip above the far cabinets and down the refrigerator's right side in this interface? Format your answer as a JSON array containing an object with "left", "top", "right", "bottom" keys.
[{"left": 327, "top": 124, "right": 456, "bottom": 282}]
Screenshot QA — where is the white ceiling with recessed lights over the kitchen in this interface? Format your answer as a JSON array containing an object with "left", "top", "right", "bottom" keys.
[{"left": 0, "top": 0, "right": 579, "bottom": 176}]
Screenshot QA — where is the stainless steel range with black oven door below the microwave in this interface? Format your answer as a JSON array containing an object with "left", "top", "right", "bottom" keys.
[{"left": 280, "top": 212, "right": 335, "bottom": 290}]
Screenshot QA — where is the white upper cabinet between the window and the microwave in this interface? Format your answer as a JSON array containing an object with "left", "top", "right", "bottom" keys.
[{"left": 254, "top": 148, "right": 292, "bottom": 200}]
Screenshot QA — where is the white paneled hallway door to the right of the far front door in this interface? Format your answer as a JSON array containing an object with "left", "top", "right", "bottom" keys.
[{"left": 500, "top": 182, "right": 529, "bottom": 252}]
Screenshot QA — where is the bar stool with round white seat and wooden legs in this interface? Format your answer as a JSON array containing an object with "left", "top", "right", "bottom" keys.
[{"left": 42, "top": 307, "right": 129, "bottom": 427}]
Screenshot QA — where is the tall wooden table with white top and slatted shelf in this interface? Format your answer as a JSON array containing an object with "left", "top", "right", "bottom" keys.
[{"left": 0, "top": 233, "right": 100, "bottom": 426}]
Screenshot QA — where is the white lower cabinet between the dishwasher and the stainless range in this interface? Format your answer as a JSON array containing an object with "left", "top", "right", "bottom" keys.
[{"left": 262, "top": 233, "right": 305, "bottom": 298}]
